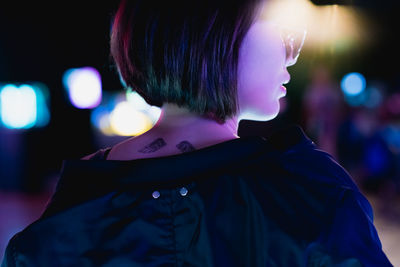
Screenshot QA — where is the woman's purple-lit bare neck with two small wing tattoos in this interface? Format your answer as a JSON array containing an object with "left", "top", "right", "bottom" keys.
[{"left": 104, "top": 104, "right": 239, "bottom": 160}]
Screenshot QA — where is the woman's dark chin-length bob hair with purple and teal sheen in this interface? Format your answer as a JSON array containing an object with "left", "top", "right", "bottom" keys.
[{"left": 110, "top": 0, "right": 264, "bottom": 123}]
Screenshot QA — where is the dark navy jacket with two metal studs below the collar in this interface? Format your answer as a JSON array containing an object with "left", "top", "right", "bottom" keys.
[{"left": 2, "top": 126, "right": 392, "bottom": 267}]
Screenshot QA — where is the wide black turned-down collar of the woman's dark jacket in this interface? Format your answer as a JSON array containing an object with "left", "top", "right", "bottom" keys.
[{"left": 42, "top": 125, "right": 312, "bottom": 217}]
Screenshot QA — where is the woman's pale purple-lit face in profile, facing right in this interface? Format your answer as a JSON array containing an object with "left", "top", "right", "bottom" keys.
[{"left": 238, "top": 20, "right": 294, "bottom": 121}]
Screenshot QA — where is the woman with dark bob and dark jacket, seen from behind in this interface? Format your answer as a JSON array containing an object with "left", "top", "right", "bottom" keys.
[{"left": 3, "top": 0, "right": 392, "bottom": 266}]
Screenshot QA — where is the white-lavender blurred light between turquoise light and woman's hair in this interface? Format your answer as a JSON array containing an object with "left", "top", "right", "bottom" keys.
[{"left": 63, "top": 67, "right": 102, "bottom": 109}]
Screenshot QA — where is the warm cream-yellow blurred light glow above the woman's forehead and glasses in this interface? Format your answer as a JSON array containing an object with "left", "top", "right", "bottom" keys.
[{"left": 263, "top": 0, "right": 370, "bottom": 49}]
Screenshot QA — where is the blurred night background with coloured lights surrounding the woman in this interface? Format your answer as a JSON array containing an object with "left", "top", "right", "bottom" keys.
[{"left": 0, "top": 0, "right": 400, "bottom": 266}]
